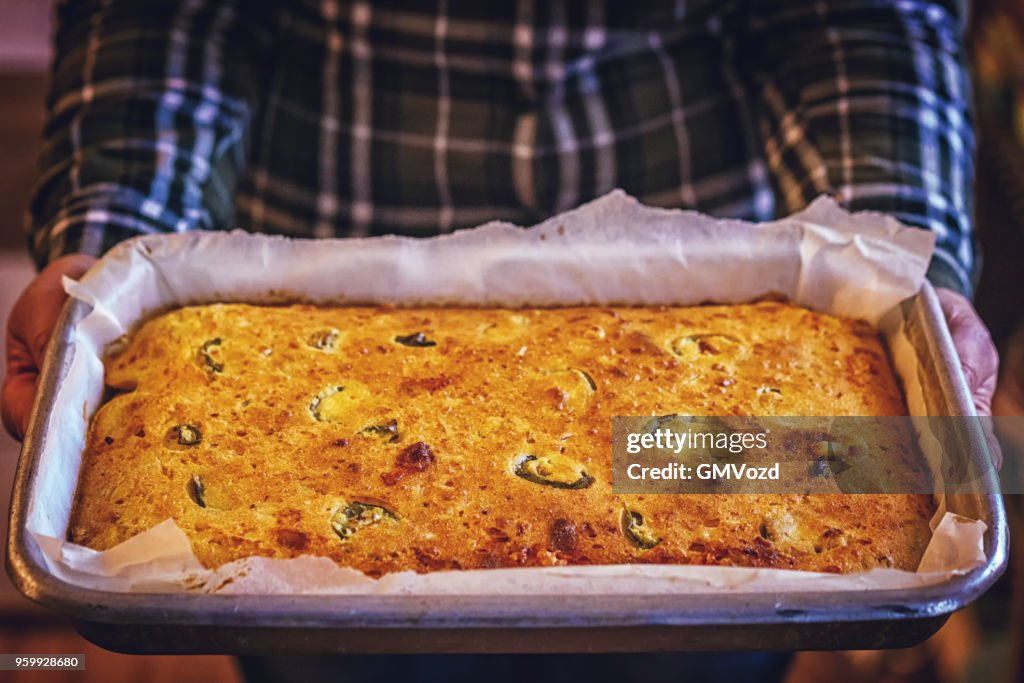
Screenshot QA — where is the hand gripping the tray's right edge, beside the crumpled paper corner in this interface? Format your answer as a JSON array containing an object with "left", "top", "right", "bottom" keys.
[{"left": 936, "top": 287, "right": 1002, "bottom": 468}]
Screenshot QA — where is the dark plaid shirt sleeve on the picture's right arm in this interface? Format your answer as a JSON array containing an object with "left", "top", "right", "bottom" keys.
[{"left": 739, "top": 0, "right": 978, "bottom": 296}]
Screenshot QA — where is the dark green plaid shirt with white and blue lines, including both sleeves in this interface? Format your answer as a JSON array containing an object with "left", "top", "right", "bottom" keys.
[{"left": 29, "top": 0, "right": 976, "bottom": 294}]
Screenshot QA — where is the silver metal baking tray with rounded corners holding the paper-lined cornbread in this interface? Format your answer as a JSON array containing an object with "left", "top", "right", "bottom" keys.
[{"left": 7, "top": 284, "right": 1008, "bottom": 654}]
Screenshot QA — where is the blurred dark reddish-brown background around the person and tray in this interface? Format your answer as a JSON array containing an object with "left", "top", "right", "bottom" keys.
[{"left": 0, "top": 0, "right": 1024, "bottom": 683}]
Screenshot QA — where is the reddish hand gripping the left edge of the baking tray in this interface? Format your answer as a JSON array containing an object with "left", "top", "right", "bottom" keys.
[{"left": 3, "top": 254, "right": 96, "bottom": 440}]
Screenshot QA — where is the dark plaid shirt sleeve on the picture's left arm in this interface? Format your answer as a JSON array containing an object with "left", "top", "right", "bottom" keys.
[{"left": 28, "top": 0, "right": 268, "bottom": 267}]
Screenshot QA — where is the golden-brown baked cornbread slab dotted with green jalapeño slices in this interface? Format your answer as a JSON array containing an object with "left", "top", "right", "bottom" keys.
[{"left": 69, "top": 302, "right": 933, "bottom": 575}]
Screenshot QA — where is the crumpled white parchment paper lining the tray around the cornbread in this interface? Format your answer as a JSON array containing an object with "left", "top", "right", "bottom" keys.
[{"left": 28, "top": 190, "right": 986, "bottom": 595}]
